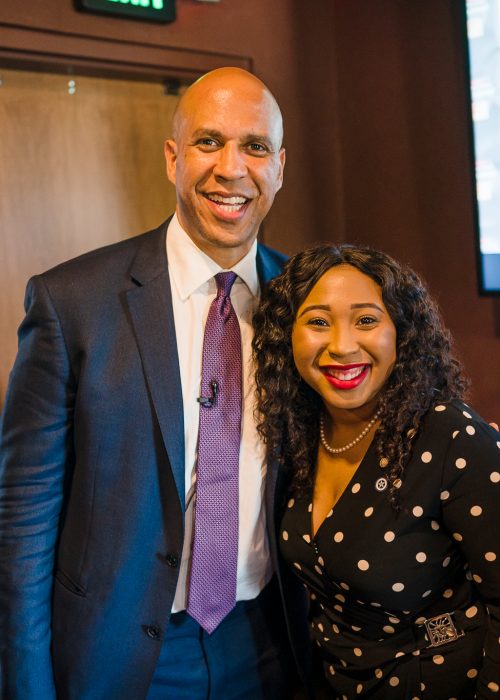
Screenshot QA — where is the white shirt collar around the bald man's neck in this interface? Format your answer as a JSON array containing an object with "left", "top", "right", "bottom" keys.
[{"left": 167, "top": 214, "right": 260, "bottom": 301}]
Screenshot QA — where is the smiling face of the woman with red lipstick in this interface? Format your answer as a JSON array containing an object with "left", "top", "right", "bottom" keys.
[{"left": 292, "top": 265, "right": 396, "bottom": 409}]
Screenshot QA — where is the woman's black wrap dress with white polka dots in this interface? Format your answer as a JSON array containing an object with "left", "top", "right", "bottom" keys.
[{"left": 280, "top": 401, "right": 500, "bottom": 700}]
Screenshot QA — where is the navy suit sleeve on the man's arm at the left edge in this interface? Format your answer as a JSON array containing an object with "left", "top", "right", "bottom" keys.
[{"left": 0, "top": 277, "right": 75, "bottom": 700}]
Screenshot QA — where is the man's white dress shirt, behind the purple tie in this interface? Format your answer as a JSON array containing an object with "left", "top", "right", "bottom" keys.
[{"left": 167, "top": 215, "right": 272, "bottom": 612}]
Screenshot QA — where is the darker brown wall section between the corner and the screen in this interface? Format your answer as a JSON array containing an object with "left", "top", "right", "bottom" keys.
[{"left": 326, "top": 0, "right": 500, "bottom": 420}]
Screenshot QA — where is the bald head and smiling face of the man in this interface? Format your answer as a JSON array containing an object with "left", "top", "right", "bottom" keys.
[{"left": 165, "top": 69, "right": 285, "bottom": 267}]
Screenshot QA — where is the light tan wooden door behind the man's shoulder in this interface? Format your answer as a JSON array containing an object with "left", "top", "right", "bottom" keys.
[{"left": 0, "top": 70, "right": 178, "bottom": 401}]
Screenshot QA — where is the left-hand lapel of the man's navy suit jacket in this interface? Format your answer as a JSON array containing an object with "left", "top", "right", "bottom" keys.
[{"left": 127, "top": 221, "right": 185, "bottom": 512}]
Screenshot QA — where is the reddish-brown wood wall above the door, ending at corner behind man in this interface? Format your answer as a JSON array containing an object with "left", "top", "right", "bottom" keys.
[{"left": 0, "top": 0, "right": 342, "bottom": 258}]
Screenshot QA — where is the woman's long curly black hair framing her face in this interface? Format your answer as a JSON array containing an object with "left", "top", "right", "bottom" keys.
[{"left": 253, "top": 244, "right": 467, "bottom": 510}]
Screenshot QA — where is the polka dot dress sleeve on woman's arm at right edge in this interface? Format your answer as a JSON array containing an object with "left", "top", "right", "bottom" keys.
[{"left": 441, "top": 407, "right": 500, "bottom": 699}]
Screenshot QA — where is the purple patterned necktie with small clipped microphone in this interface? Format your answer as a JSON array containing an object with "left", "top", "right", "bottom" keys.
[{"left": 187, "top": 272, "right": 242, "bottom": 633}]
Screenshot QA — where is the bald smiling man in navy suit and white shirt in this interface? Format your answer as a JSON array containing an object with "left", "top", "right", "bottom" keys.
[{"left": 0, "top": 68, "right": 307, "bottom": 700}]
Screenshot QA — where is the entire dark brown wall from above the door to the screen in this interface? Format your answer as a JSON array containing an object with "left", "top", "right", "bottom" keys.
[{"left": 0, "top": 0, "right": 500, "bottom": 419}]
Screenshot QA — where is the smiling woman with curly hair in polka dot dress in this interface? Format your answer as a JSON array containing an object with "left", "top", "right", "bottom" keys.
[{"left": 254, "top": 245, "right": 500, "bottom": 700}]
